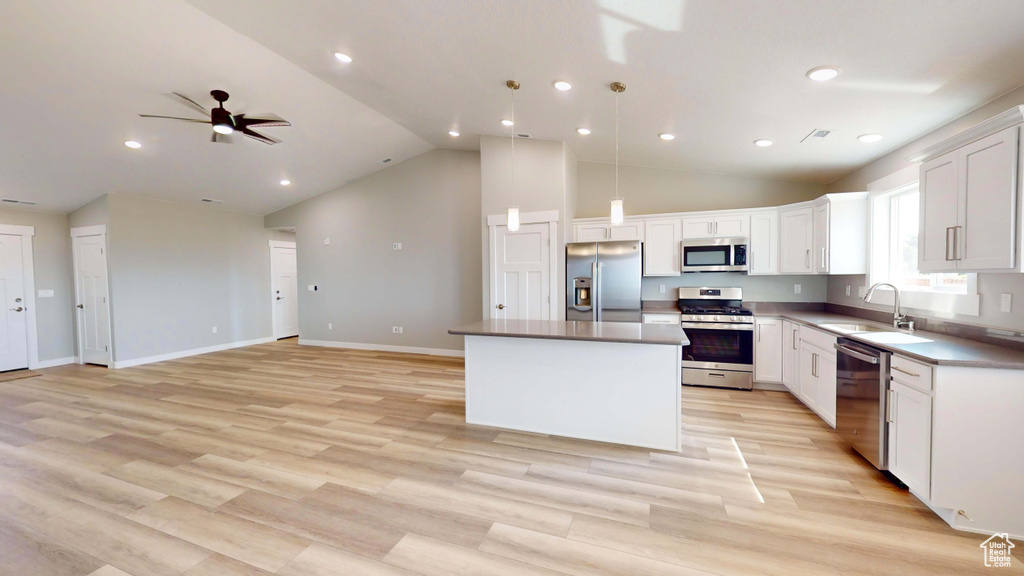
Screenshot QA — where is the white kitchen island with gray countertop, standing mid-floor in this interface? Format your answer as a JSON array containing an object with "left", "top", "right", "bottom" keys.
[{"left": 449, "top": 320, "right": 689, "bottom": 451}]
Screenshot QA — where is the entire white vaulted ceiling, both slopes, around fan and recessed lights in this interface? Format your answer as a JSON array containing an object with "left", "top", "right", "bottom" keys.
[{"left": 6, "top": 0, "right": 1024, "bottom": 213}]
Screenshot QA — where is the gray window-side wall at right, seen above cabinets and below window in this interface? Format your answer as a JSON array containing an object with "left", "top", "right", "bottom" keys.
[{"left": 828, "top": 86, "right": 1024, "bottom": 331}]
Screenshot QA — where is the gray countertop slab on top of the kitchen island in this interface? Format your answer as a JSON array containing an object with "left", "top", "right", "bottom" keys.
[{"left": 449, "top": 320, "right": 690, "bottom": 346}]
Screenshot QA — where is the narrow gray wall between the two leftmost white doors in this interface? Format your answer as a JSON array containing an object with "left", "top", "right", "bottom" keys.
[{"left": 0, "top": 204, "right": 75, "bottom": 362}]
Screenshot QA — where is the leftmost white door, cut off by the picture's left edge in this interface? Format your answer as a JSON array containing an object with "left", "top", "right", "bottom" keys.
[{"left": 0, "top": 234, "right": 29, "bottom": 371}]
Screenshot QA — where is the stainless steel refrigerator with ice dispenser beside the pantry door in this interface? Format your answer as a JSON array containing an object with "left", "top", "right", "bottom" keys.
[{"left": 565, "top": 240, "right": 643, "bottom": 322}]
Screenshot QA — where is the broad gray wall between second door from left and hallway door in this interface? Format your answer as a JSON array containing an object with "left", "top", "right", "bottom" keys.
[{"left": 103, "top": 195, "right": 272, "bottom": 362}]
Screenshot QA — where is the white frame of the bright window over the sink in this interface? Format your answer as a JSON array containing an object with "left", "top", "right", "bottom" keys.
[{"left": 867, "top": 181, "right": 981, "bottom": 316}]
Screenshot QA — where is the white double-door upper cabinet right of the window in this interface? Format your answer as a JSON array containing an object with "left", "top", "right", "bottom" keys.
[{"left": 911, "top": 107, "right": 1024, "bottom": 272}]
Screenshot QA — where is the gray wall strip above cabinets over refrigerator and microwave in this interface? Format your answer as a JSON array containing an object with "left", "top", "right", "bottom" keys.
[{"left": 575, "top": 162, "right": 824, "bottom": 218}]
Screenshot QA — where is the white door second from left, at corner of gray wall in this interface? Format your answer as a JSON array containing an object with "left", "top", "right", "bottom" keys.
[{"left": 73, "top": 234, "right": 111, "bottom": 366}]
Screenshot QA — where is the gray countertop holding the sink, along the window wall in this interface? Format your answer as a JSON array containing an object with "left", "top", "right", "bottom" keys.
[{"left": 761, "top": 312, "right": 1024, "bottom": 370}]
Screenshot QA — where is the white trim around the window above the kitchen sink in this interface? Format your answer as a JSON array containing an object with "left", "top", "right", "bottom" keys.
[{"left": 867, "top": 179, "right": 981, "bottom": 318}]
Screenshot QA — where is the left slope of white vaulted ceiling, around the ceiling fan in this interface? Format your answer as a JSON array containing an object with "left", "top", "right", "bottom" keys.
[{"left": 0, "top": 0, "right": 431, "bottom": 214}]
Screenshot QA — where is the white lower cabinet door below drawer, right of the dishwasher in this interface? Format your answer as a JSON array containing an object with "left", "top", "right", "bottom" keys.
[{"left": 887, "top": 380, "right": 932, "bottom": 498}]
